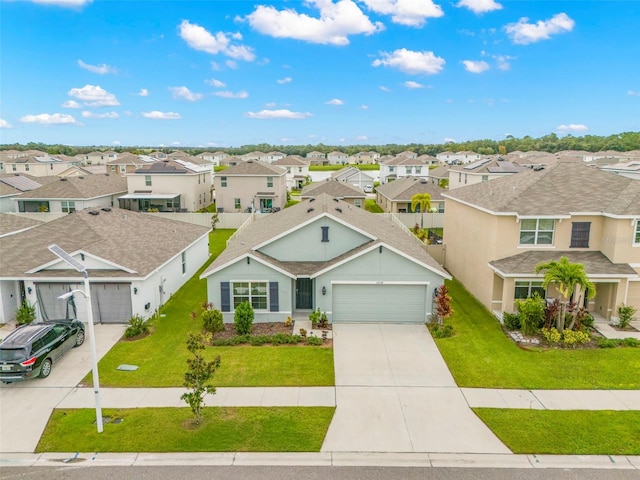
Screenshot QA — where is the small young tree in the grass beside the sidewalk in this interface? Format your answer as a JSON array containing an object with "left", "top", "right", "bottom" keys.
[{"left": 180, "top": 333, "right": 220, "bottom": 425}]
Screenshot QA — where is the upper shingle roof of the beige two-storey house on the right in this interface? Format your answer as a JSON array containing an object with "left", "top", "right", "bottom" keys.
[{"left": 444, "top": 162, "right": 640, "bottom": 216}]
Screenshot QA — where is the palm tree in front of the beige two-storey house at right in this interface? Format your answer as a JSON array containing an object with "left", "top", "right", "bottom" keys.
[{"left": 536, "top": 257, "right": 596, "bottom": 332}]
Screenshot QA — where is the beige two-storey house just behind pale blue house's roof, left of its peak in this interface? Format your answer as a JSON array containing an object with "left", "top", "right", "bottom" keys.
[{"left": 214, "top": 160, "right": 287, "bottom": 213}]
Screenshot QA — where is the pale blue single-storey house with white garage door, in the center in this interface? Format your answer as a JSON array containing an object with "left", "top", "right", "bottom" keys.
[{"left": 201, "top": 194, "right": 451, "bottom": 324}]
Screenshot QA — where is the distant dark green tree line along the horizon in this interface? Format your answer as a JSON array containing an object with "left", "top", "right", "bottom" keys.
[{"left": 0, "top": 132, "right": 640, "bottom": 157}]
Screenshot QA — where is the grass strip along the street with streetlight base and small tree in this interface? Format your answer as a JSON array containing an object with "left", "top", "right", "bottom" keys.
[{"left": 36, "top": 407, "right": 335, "bottom": 452}]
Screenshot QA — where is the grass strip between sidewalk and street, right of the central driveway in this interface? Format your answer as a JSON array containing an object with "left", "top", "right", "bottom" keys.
[{"left": 473, "top": 408, "right": 640, "bottom": 455}]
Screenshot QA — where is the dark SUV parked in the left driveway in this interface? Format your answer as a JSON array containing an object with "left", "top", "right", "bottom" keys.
[{"left": 0, "top": 320, "right": 84, "bottom": 383}]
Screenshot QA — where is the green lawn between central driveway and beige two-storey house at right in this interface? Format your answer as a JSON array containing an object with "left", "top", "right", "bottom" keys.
[{"left": 436, "top": 280, "right": 640, "bottom": 390}]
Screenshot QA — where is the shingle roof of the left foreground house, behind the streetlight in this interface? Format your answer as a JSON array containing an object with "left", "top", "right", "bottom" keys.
[{"left": 0, "top": 208, "right": 210, "bottom": 278}]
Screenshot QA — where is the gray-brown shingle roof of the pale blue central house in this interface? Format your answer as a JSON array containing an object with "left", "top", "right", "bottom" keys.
[{"left": 202, "top": 194, "right": 449, "bottom": 278}]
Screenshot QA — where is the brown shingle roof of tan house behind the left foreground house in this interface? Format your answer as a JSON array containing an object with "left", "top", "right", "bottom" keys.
[{"left": 15, "top": 174, "right": 127, "bottom": 200}]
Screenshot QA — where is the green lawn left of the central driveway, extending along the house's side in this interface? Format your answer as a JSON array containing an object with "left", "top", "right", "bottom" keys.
[{"left": 91, "top": 230, "right": 334, "bottom": 387}]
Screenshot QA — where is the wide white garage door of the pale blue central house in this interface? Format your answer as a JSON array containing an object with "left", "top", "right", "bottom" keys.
[{"left": 332, "top": 284, "right": 427, "bottom": 323}]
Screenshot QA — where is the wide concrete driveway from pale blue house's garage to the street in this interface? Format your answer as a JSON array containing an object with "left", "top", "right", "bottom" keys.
[{"left": 322, "top": 324, "right": 510, "bottom": 453}]
